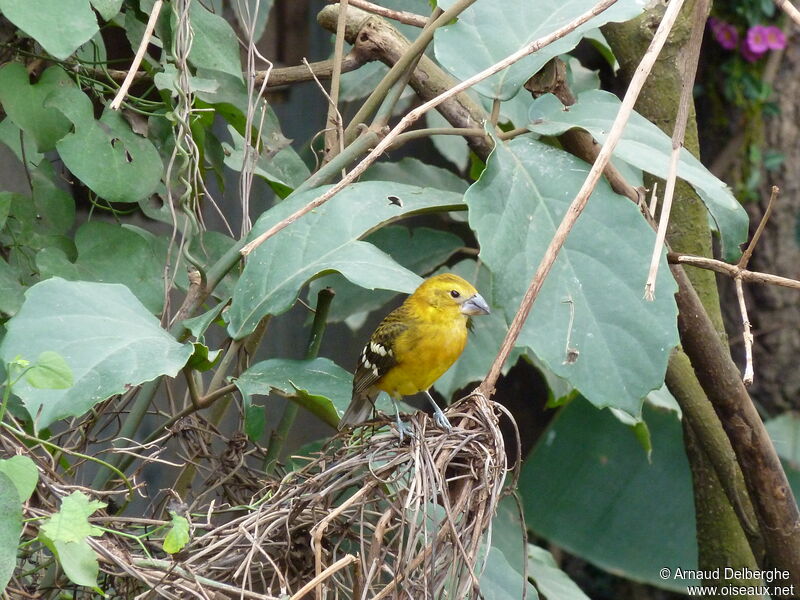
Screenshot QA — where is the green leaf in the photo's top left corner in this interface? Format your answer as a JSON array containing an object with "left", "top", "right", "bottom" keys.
[{"left": 0, "top": 0, "right": 98, "bottom": 60}]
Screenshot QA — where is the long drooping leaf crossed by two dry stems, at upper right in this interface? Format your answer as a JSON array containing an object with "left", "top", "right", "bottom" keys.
[{"left": 529, "top": 90, "right": 748, "bottom": 262}]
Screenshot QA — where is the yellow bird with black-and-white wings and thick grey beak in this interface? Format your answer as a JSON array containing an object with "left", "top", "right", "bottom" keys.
[{"left": 339, "top": 273, "right": 489, "bottom": 439}]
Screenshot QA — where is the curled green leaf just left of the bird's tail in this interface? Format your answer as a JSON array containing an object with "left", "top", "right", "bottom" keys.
[{"left": 235, "top": 358, "right": 353, "bottom": 427}]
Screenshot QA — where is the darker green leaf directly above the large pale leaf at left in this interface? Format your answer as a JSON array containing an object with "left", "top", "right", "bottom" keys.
[{"left": 36, "top": 221, "right": 166, "bottom": 314}]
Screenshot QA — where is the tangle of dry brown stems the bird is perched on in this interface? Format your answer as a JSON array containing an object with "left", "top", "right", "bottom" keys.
[{"left": 0, "top": 392, "right": 509, "bottom": 600}]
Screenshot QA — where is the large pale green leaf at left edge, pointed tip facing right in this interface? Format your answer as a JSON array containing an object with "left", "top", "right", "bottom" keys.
[{"left": 0, "top": 278, "right": 192, "bottom": 428}]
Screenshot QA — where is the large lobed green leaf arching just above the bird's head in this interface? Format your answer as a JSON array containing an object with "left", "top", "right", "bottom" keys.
[{"left": 228, "top": 181, "right": 463, "bottom": 339}]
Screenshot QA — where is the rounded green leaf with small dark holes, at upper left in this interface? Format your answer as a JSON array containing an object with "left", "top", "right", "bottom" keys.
[{"left": 45, "top": 88, "right": 163, "bottom": 202}]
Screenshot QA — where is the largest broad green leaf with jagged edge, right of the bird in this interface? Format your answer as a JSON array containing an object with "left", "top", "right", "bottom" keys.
[{"left": 465, "top": 137, "right": 678, "bottom": 416}]
